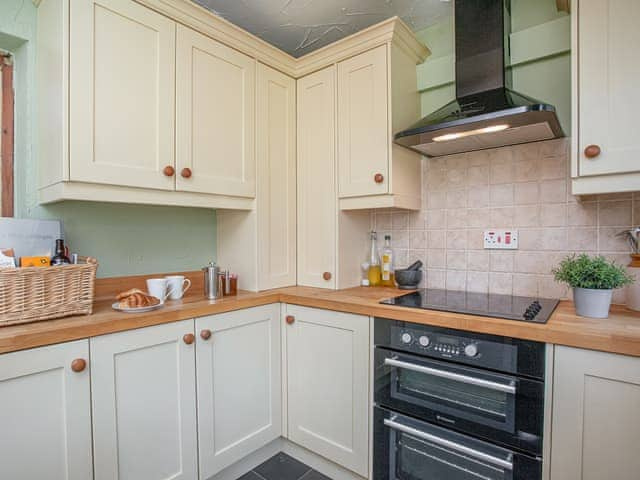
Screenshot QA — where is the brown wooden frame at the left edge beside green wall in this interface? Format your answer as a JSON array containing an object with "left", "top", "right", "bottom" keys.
[{"left": 0, "top": 55, "right": 15, "bottom": 217}]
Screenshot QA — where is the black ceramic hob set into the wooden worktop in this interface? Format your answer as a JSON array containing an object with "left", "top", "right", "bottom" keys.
[{"left": 380, "top": 288, "right": 558, "bottom": 323}]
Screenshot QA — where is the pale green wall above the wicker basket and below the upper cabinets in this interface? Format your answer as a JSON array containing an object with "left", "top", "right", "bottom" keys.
[{"left": 0, "top": 0, "right": 216, "bottom": 277}]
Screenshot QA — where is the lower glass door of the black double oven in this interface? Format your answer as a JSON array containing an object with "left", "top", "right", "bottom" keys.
[{"left": 373, "top": 408, "right": 541, "bottom": 480}]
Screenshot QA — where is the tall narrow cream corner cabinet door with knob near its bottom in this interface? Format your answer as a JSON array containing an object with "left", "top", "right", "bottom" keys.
[{"left": 298, "top": 66, "right": 337, "bottom": 288}]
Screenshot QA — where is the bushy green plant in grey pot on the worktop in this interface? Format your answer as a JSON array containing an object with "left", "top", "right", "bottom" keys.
[{"left": 553, "top": 254, "right": 633, "bottom": 318}]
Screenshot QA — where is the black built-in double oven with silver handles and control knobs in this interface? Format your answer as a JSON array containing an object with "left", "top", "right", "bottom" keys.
[{"left": 373, "top": 319, "right": 545, "bottom": 480}]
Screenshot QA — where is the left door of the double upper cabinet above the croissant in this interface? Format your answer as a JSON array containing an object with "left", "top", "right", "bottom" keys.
[{"left": 69, "top": 0, "right": 175, "bottom": 190}]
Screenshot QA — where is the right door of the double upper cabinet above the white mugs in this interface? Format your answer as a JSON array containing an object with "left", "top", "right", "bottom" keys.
[{"left": 176, "top": 26, "right": 256, "bottom": 197}]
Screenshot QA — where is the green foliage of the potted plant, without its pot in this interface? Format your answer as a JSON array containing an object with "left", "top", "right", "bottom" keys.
[{"left": 552, "top": 253, "right": 633, "bottom": 290}]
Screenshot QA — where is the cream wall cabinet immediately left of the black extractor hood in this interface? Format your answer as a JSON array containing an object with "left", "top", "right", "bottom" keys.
[{"left": 337, "top": 43, "right": 424, "bottom": 210}]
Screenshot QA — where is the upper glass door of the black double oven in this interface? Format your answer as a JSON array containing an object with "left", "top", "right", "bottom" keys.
[{"left": 375, "top": 348, "right": 544, "bottom": 453}]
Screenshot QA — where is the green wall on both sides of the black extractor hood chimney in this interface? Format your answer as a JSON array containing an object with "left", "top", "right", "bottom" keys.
[{"left": 417, "top": 0, "right": 571, "bottom": 135}]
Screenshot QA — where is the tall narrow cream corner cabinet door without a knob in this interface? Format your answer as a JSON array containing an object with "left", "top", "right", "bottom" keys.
[{"left": 257, "top": 64, "right": 296, "bottom": 290}]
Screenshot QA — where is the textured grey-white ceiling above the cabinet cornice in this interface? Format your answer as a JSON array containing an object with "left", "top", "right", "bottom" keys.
[{"left": 193, "top": 0, "right": 453, "bottom": 57}]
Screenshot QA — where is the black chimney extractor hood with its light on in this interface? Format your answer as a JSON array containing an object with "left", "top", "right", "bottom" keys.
[{"left": 395, "top": 0, "right": 564, "bottom": 157}]
